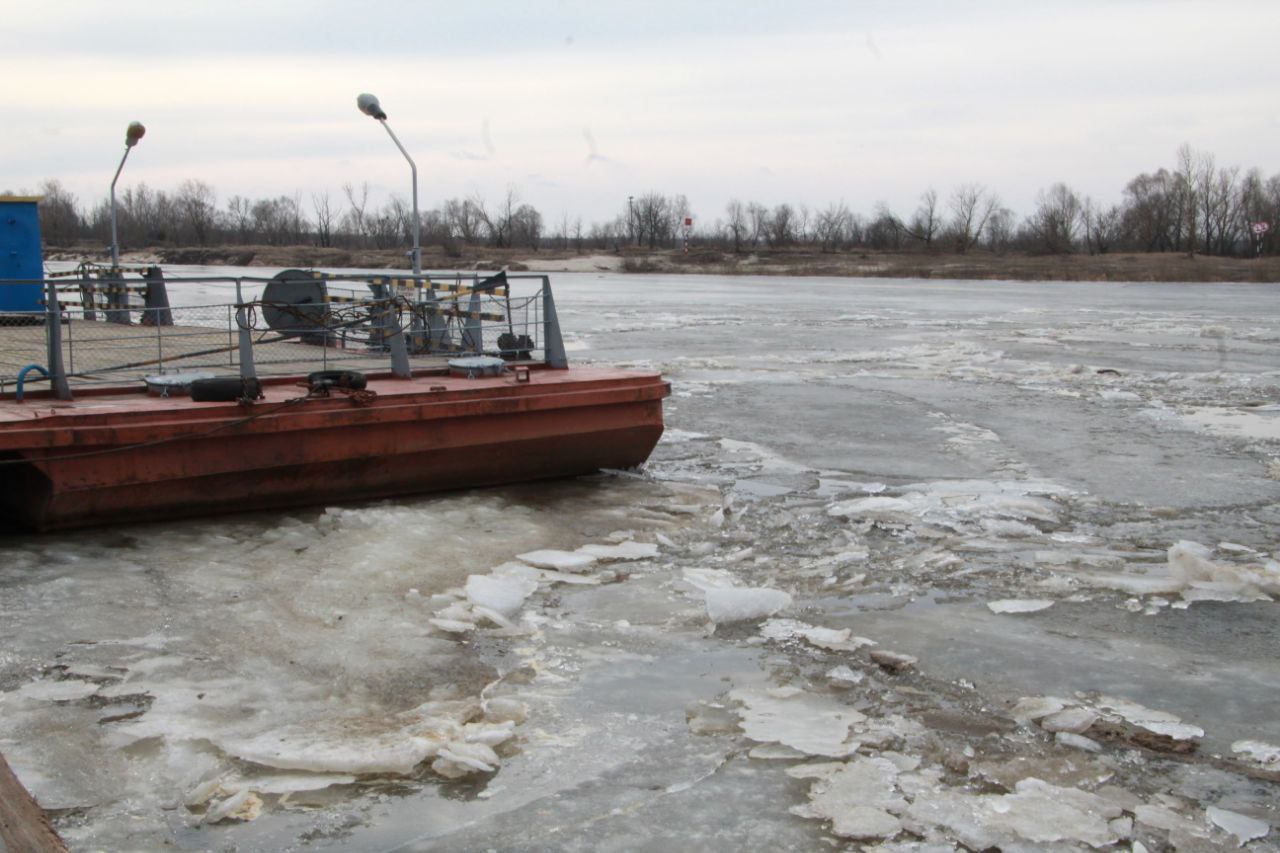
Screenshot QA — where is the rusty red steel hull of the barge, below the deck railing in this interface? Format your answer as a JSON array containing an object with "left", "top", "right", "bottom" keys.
[{"left": 0, "top": 368, "right": 669, "bottom": 530}]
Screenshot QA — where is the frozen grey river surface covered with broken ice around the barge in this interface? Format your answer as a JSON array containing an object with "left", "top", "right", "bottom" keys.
[{"left": 0, "top": 270, "right": 1280, "bottom": 850}]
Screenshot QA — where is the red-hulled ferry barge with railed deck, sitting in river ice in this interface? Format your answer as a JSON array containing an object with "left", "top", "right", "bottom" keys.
[{"left": 0, "top": 253, "right": 669, "bottom": 530}]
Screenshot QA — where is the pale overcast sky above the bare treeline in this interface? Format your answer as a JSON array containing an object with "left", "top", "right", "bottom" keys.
[{"left": 0, "top": 0, "right": 1280, "bottom": 224}]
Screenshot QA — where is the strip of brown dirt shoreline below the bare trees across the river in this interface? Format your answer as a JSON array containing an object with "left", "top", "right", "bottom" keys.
[{"left": 45, "top": 246, "right": 1280, "bottom": 283}]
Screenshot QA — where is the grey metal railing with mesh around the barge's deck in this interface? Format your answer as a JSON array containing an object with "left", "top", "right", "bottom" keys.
[{"left": 0, "top": 268, "right": 567, "bottom": 398}]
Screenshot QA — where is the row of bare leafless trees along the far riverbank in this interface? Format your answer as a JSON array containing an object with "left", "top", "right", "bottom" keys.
[{"left": 17, "top": 145, "right": 1280, "bottom": 256}]
